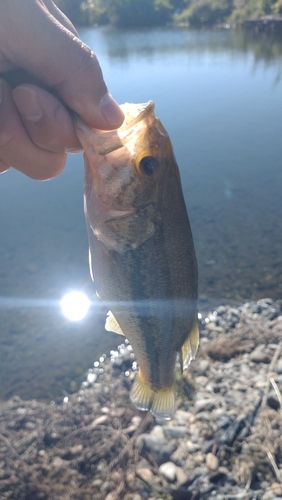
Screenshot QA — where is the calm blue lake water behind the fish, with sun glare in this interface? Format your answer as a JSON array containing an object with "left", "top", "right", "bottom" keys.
[{"left": 0, "top": 28, "right": 282, "bottom": 399}]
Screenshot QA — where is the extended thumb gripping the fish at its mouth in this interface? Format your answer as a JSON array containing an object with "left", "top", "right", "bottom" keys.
[{"left": 0, "top": 0, "right": 123, "bottom": 130}]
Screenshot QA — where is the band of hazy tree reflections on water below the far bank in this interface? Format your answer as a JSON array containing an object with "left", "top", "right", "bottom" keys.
[{"left": 91, "top": 28, "right": 282, "bottom": 81}]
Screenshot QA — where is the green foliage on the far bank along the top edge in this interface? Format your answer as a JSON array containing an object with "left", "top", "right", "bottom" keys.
[{"left": 55, "top": 0, "right": 282, "bottom": 28}]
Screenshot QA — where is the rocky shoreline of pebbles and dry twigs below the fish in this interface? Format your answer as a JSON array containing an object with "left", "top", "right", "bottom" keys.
[{"left": 0, "top": 299, "right": 282, "bottom": 500}]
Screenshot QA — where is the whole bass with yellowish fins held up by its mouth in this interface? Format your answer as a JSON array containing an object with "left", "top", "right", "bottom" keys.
[{"left": 76, "top": 101, "right": 199, "bottom": 420}]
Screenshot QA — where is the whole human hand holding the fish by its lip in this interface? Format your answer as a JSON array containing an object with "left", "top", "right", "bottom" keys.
[{"left": 0, "top": 0, "right": 123, "bottom": 180}]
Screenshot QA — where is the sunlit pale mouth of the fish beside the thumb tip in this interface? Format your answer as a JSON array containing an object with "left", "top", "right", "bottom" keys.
[{"left": 75, "top": 101, "right": 155, "bottom": 155}]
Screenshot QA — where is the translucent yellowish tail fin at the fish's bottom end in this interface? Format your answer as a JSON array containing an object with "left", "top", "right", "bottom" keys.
[{"left": 130, "top": 372, "right": 174, "bottom": 420}]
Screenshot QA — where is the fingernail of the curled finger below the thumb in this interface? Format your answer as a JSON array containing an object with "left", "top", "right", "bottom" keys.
[{"left": 13, "top": 85, "right": 42, "bottom": 123}]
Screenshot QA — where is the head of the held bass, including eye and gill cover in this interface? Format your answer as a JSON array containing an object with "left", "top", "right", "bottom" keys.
[{"left": 76, "top": 101, "right": 173, "bottom": 251}]
